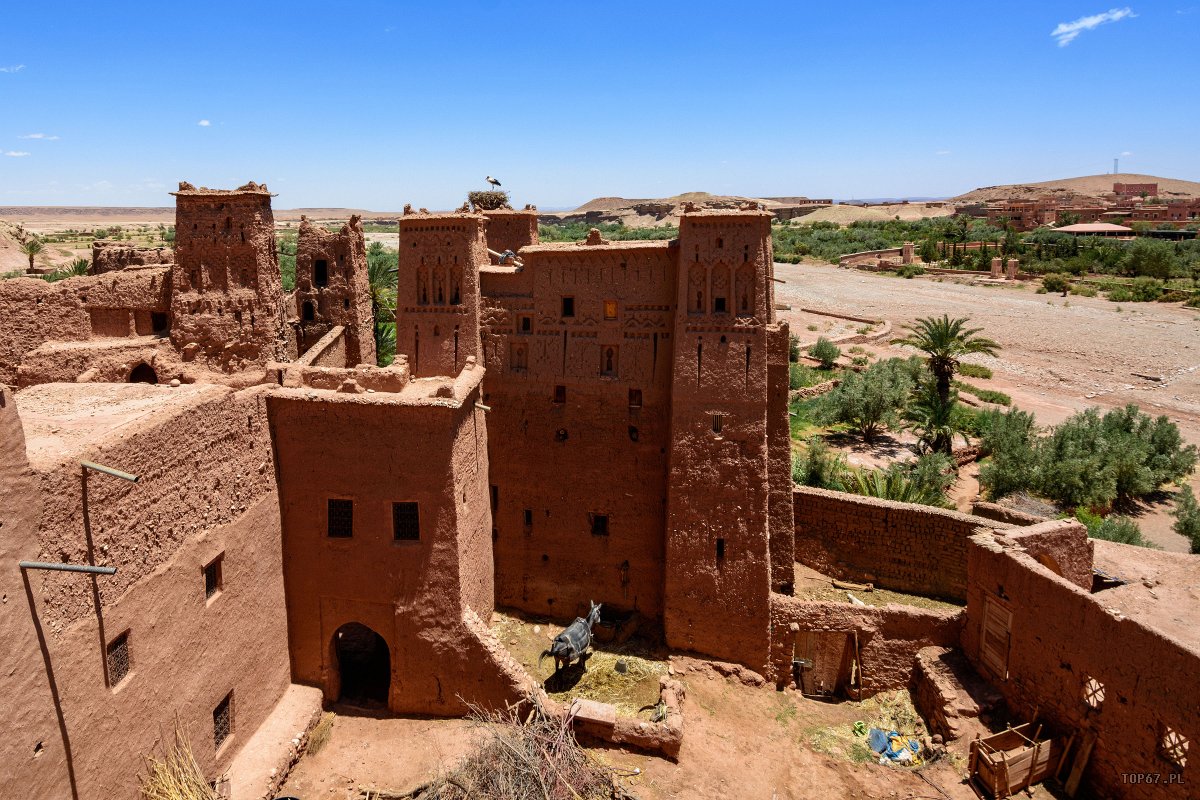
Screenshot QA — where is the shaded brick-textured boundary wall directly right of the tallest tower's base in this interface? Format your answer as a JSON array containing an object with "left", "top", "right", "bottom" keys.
[{"left": 793, "top": 487, "right": 1010, "bottom": 600}]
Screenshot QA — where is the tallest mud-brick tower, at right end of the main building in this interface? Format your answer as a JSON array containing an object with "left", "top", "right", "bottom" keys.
[{"left": 664, "top": 209, "right": 791, "bottom": 666}]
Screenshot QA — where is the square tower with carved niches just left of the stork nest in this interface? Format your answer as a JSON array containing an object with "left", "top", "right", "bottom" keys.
[{"left": 396, "top": 207, "right": 487, "bottom": 378}]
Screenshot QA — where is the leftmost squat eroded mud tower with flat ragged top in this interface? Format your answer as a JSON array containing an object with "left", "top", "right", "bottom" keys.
[{"left": 170, "top": 181, "right": 288, "bottom": 371}]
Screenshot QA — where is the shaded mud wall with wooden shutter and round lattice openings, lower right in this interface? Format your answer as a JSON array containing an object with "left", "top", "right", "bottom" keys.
[{"left": 962, "top": 536, "right": 1200, "bottom": 798}]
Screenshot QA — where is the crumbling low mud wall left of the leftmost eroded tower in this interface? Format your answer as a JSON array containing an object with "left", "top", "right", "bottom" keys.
[{"left": 0, "top": 267, "right": 170, "bottom": 383}]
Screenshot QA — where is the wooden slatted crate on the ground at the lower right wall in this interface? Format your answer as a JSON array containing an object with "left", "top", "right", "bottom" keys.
[{"left": 968, "top": 722, "right": 1063, "bottom": 800}]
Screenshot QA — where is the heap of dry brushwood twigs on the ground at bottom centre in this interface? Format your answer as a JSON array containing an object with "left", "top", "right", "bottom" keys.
[{"left": 362, "top": 699, "right": 632, "bottom": 800}]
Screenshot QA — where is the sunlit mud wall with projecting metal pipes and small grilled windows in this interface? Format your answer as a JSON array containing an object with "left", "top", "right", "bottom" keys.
[{"left": 0, "top": 381, "right": 288, "bottom": 798}]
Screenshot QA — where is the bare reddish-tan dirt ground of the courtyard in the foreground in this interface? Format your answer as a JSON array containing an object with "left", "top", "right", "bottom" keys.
[{"left": 280, "top": 658, "right": 1050, "bottom": 800}]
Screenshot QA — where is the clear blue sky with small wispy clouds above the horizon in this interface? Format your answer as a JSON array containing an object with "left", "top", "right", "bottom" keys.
[{"left": 0, "top": 0, "right": 1200, "bottom": 210}]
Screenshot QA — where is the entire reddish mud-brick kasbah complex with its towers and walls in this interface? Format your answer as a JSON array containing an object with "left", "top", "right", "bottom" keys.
[{"left": 0, "top": 182, "right": 1200, "bottom": 800}]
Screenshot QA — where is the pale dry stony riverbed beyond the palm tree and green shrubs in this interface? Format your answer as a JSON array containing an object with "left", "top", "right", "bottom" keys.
[{"left": 775, "top": 264, "right": 1200, "bottom": 552}]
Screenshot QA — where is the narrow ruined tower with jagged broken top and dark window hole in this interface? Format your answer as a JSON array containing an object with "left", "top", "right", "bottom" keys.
[{"left": 292, "top": 216, "right": 376, "bottom": 363}]
